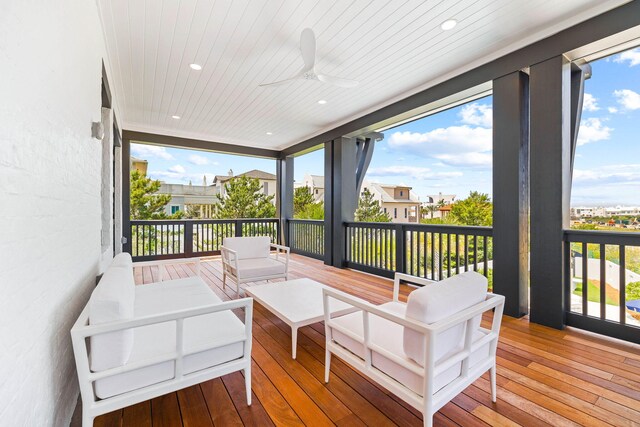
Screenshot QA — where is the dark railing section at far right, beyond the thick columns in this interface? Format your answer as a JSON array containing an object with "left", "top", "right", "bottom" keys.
[{"left": 564, "top": 230, "right": 640, "bottom": 343}]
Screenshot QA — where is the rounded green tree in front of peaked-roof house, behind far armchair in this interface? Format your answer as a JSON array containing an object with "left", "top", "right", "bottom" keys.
[{"left": 215, "top": 176, "right": 276, "bottom": 219}]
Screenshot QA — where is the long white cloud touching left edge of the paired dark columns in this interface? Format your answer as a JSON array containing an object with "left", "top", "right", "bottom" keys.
[{"left": 389, "top": 125, "right": 493, "bottom": 167}]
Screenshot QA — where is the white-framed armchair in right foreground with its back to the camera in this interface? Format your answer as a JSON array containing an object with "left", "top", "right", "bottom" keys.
[{"left": 323, "top": 271, "right": 504, "bottom": 426}]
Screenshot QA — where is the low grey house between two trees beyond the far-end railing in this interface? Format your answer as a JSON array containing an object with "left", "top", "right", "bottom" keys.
[{"left": 158, "top": 182, "right": 218, "bottom": 219}]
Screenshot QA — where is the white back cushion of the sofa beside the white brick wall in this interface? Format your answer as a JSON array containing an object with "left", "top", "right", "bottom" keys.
[{"left": 89, "top": 256, "right": 135, "bottom": 372}]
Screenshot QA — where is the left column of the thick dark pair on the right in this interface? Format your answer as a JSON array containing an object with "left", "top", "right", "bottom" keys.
[{"left": 493, "top": 71, "right": 529, "bottom": 317}]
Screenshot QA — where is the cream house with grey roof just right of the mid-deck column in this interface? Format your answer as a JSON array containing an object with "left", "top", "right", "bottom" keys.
[{"left": 362, "top": 181, "right": 420, "bottom": 222}]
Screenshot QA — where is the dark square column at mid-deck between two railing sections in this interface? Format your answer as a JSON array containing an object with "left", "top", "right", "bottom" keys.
[{"left": 324, "top": 137, "right": 358, "bottom": 267}]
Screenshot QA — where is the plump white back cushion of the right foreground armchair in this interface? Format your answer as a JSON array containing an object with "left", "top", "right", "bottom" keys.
[{"left": 403, "top": 271, "right": 488, "bottom": 365}]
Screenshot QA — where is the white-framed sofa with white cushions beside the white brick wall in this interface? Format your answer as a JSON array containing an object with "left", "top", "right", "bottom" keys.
[{"left": 71, "top": 254, "right": 253, "bottom": 427}]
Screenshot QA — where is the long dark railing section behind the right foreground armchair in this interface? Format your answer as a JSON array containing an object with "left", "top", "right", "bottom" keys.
[{"left": 345, "top": 222, "right": 493, "bottom": 281}]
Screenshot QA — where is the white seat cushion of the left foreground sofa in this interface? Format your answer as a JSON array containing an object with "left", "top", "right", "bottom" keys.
[{"left": 95, "top": 277, "right": 245, "bottom": 399}]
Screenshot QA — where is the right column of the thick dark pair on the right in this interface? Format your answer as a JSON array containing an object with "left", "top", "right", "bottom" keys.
[{"left": 529, "top": 55, "right": 571, "bottom": 329}]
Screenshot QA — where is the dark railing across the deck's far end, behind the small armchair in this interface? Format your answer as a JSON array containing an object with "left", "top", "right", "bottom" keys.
[{"left": 130, "top": 218, "right": 280, "bottom": 261}]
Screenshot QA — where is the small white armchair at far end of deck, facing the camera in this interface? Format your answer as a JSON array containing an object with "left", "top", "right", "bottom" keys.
[{"left": 220, "top": 236, "right": 289, "bottom": 295}]
